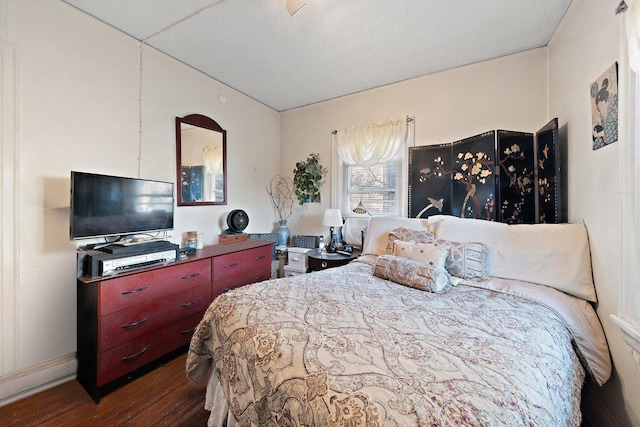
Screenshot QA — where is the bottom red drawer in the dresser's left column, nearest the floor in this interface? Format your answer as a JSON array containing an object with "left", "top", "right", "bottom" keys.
[{"left": 97, "top": 312, "right": 204, "bottom": 386}]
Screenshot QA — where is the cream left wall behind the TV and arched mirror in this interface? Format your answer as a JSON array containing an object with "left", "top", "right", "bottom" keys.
[{"left": 0, "top": 0, "right": 279, "bottom": 402}]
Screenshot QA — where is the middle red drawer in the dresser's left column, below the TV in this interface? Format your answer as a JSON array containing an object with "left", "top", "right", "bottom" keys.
[{"left": 98, "top": 284, "right": 211, "bottom": 351}]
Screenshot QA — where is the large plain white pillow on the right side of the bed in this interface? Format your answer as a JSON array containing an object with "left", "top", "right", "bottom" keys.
[{"left": 429, "top": 215, "right": 596, "bottom": 302}]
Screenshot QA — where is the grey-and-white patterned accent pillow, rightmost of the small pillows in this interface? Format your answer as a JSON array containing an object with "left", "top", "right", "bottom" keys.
[{"left": 433, "top": 239, "right": 491, "bottom": 279}]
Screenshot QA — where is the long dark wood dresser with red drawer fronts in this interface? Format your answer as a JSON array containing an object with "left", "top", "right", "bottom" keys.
[{"left": 77, "top": 240, "right": 272, "bottom": 403}]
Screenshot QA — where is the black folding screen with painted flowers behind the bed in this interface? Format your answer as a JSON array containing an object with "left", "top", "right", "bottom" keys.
[{"left": 409, "top": 119, "right": 561, "bottom": 224}]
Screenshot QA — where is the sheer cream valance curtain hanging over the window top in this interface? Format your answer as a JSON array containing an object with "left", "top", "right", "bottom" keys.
[{"left": 336, "top": 117, "right": 408, "bottom": 167}]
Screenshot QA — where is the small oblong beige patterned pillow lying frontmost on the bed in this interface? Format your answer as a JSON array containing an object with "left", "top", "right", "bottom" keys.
[{"left": 373, "top": 255, "right": 451, "bottom": 294}]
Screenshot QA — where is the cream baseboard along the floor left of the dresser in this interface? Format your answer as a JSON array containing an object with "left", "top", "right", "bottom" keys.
[{"left": 0, "top": 353, "right": 78, "bottom": 407}]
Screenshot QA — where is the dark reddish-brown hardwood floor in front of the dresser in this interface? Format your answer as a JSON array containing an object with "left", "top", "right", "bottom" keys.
[{"left": 0, "top": 354, "right": 209, "bottom": 427}]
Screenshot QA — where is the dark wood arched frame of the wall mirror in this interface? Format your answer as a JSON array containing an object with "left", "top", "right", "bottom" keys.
[{"left": 176, "top": 114, "right": 227, "bottom": 206}]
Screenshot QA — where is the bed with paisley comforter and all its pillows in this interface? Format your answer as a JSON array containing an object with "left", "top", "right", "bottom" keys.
[{"left": 186, "top": 216, "right": 611, "bottom": 427}]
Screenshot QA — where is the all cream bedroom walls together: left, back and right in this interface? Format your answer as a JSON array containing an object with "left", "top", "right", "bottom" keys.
[{"left": 0, "top": 0, "right": 640, "bottom": 425}]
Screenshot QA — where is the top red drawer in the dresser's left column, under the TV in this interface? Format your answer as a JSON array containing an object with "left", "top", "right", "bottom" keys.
[{"left": 98, "top": 260, "right": 211, "bottom": 316}]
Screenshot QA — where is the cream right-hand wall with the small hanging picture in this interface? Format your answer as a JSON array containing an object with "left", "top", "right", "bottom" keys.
[{"left": 549, "top": 0, "right": 640, "bottom": 426}]
